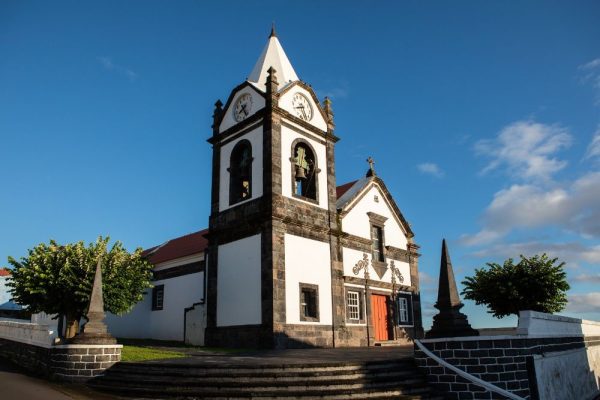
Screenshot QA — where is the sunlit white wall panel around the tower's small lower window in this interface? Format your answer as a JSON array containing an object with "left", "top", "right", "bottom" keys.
[{"left": 284, "top": 234, "right": 332, "bottom": 325}]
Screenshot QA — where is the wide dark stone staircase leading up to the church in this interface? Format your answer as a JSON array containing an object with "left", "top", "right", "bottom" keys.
[{"left": 88, "top": 358, "right": 443, "bottom": 400}]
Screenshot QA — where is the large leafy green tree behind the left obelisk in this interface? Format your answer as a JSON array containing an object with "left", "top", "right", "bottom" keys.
[{"left": 8, "top": 236, "right": 152, "bottom": 338}]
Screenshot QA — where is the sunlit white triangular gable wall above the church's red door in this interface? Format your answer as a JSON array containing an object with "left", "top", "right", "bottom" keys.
[{"left": 342, "top": 183, "right": 408, "bottom": 250}]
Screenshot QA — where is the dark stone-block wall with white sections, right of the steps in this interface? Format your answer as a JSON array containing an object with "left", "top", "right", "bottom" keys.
[{"left": 415, "top": 311, "right": 600, "bottom": 400}]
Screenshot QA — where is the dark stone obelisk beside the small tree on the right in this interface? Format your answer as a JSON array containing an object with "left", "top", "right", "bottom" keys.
[{"left": 425, "top": 239, "right": 479, "bottom": 338}]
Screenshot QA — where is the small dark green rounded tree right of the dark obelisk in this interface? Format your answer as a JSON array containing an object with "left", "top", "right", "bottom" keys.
[{"left": 461, "top": 253, "right": 570, "bottom": 318}]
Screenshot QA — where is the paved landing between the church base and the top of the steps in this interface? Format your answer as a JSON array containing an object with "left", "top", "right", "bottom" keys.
[{"left": 142, "top": 346, "right": 413, "bottom": 366}]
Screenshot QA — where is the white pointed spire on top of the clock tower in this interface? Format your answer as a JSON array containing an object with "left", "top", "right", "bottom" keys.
[{"left": 248, "top": 27, "right": 298, "bottom": 91}]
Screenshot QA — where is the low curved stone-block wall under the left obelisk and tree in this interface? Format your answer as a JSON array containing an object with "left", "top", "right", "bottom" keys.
[{"left": 0, "top": 321, "right": 123, "bottom": 382}]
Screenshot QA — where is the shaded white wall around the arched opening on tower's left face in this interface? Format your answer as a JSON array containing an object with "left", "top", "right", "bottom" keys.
[{"left": 219, "top": 125, "right": 263, "bottom": 211}]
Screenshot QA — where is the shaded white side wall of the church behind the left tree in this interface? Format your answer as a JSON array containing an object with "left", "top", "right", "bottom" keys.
[{"left": 106, "top": 272, "right": 204, "bottom": 340}]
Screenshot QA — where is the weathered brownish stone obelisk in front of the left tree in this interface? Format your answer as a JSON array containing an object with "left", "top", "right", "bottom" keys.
[{"left": 71, "top": 259, "right": 117, "bottom": 344}]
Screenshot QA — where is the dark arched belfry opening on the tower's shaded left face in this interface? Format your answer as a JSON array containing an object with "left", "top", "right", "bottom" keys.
[{"left": 228, "top": 140, "right": 253, "bottom": 204}]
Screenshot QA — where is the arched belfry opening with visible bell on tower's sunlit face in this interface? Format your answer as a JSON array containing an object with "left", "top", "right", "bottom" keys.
[{"left": 291, "top": 141, "right": 319, "bottom": 200}]
